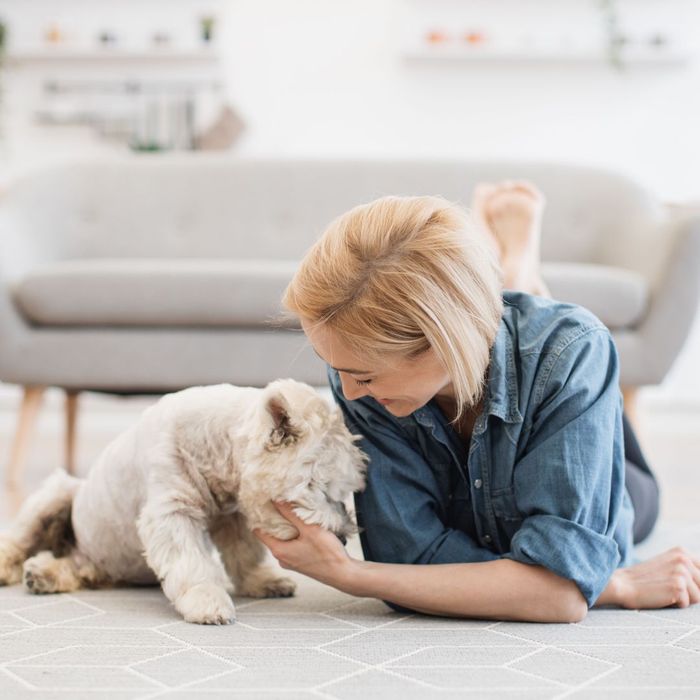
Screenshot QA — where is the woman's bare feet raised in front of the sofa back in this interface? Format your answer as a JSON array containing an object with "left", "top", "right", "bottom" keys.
[{"left": 472, "top": 181, "right": 549, "bottom": 296}]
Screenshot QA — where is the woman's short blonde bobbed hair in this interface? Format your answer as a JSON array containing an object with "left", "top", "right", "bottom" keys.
[{"left": 282, "top": 197, "right": 503, "bottom": 420}]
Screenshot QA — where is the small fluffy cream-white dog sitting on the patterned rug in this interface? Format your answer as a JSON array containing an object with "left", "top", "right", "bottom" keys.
[{"left": 0, "top": 379, "right": 366, "bottom": 624}]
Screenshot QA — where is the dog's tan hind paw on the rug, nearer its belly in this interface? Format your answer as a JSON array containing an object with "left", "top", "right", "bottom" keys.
[{"left": 22, "top": 549, "right": 106, "bottom": 593}]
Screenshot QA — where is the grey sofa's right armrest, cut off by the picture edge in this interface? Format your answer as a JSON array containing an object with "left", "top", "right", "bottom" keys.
[{"left": 632, "top": 216, "right": 700, "bottom": 384}]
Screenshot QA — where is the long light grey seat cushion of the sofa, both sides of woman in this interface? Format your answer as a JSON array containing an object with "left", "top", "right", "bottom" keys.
[{"left": 13, "top": 258, "right": 649, "bottom": 329}]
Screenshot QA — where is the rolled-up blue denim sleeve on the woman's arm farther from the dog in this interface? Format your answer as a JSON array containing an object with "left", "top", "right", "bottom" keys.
[{"left": 505, "top": 327, "right": 625, "bottom": 606}]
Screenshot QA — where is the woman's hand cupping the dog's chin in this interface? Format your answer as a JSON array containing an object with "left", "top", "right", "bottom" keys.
[{"left": 253, "top": 501, "right": 356, "bottom": 590}]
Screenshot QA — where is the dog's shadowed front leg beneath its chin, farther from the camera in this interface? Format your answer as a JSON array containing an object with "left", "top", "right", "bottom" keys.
[{"left": 210, "top": 513, "right": 296, "bottom": 598}]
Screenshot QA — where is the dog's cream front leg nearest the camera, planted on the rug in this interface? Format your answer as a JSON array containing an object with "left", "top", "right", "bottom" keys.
[{"left": 138, "top": 503, "right": 236, "bottom": 625}]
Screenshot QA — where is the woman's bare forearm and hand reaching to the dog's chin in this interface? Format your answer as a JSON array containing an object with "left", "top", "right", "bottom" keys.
[{"left": 256, "top": 503, "right": 588, "bottom": 622}]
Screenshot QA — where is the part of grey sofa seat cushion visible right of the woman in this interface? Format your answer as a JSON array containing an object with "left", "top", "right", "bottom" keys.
[{"left": 542, "top": 263, "right": 649, "bottom": 330}]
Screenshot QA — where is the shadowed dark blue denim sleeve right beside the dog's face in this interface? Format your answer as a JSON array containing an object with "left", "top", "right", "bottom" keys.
[{"left": 328, "top": 369, "right": 499, "bottom": 564}]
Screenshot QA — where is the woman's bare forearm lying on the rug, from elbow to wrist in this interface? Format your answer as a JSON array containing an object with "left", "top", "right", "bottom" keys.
[{"left": 332, "top": 559, "right": 588, "bottom": 622}]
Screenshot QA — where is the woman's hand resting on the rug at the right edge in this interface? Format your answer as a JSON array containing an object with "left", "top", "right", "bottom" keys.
[{"left": 598, "top": 547, "right": 700, "bottom": 609}]
